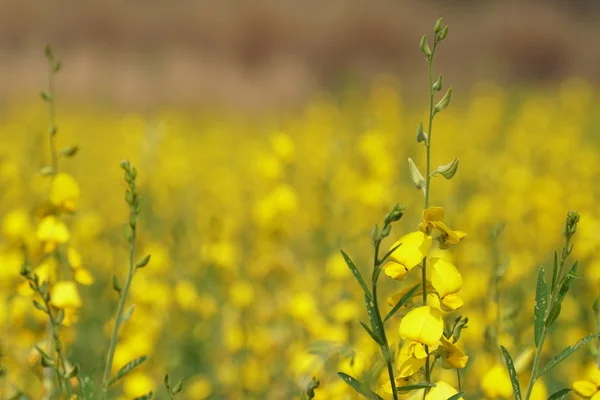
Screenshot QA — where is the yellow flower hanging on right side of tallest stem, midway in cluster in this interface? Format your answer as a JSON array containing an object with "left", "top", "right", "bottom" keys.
[{"left": 430, "top": 257, "right": 463, "bottom": 311}]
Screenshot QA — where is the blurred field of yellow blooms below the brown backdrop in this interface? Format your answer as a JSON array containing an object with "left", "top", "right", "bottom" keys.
[{"left": 0, "top": 28, "right": 600, "bottom": 400}]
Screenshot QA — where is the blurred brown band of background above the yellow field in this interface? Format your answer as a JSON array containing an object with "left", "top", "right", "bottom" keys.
[{"left": 0, "top": 0, "right": 600, "bottom": 110}]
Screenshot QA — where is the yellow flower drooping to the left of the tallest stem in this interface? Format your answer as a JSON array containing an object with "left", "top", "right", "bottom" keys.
[{"left": 383, "top": 232, "right": 431, "bottom": 280}]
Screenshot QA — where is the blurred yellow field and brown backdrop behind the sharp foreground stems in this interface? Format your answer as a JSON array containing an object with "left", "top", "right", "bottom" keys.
[{"left": 0, "top": 0, "right": 600, "bottom": 400}]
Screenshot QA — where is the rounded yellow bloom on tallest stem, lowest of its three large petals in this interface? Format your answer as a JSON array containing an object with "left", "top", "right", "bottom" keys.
[{"left": 400, "top": 306, "right": 444, "bottom": 346}]
